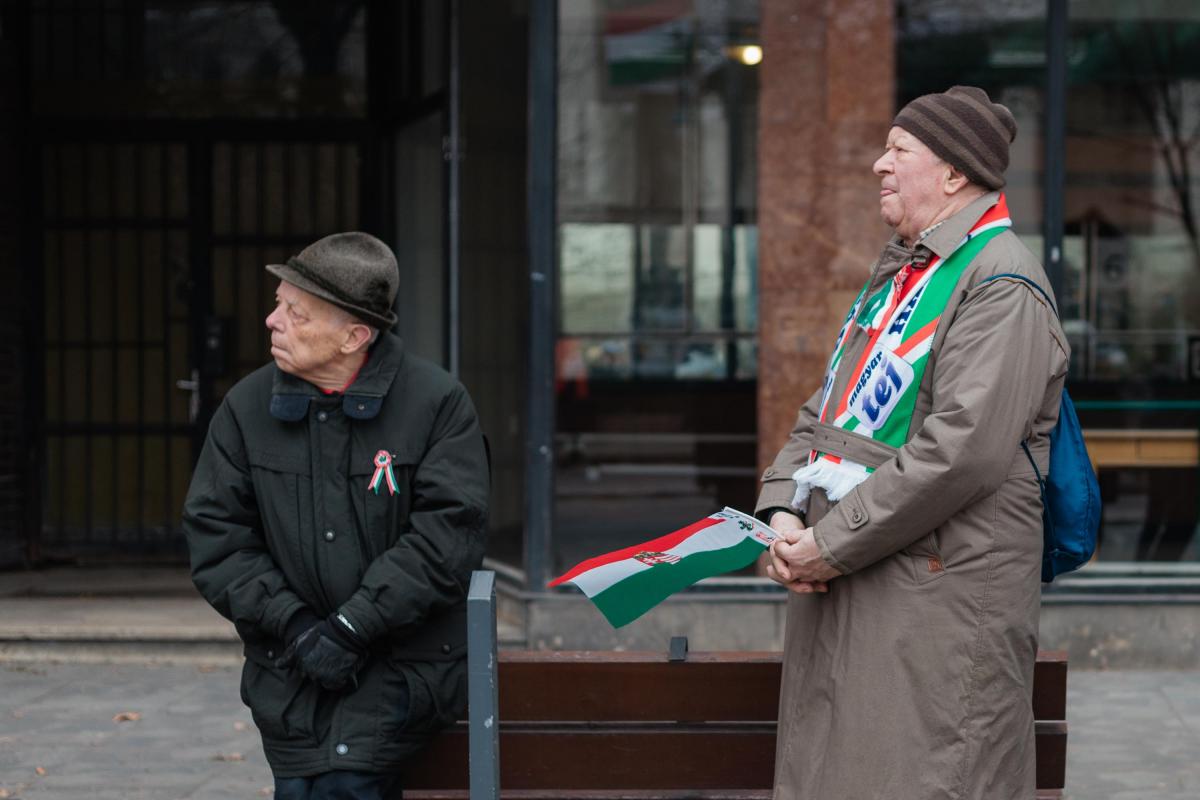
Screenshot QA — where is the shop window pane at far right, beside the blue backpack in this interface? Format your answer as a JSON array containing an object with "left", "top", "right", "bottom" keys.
[{"left": 1063, "top": 0, "right": 1200, "bottom": 561}]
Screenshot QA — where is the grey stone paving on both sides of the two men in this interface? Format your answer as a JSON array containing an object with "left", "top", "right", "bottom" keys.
[{"left": 0, "top": 663, "right": 1200, "bottom": 800}]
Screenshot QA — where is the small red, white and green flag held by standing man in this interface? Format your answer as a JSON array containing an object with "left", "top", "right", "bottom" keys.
[{"left": 550, "top": 507, "right": 779, "bottom": 627}]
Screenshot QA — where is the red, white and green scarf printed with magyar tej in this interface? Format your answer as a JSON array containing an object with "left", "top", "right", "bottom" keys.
[{"left": 792, "top": 196, "right": 1013, "bottom": 510}]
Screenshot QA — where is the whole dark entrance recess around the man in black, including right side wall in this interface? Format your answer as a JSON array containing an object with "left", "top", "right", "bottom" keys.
[{"left": 9, "top": 0, "right": 527, "bottom": 575}]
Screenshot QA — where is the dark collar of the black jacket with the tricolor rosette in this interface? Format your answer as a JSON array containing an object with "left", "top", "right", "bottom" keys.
[{"left": 270, "top": 331, "right": 404, "bottom": 422}]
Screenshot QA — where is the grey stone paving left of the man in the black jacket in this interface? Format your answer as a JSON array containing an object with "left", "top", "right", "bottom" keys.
[{"left": 0, "top": 663, "right": 272, "bottom": 800}]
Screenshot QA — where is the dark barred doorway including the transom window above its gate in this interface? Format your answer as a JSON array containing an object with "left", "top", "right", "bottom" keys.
[{"left": 15, "top": 0, "right": 393, "bottom": 563}]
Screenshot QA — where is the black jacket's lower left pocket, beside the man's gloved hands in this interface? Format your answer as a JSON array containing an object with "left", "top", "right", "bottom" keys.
[{"left": 241, "top": 646, "right": 317, "bottom": 744}]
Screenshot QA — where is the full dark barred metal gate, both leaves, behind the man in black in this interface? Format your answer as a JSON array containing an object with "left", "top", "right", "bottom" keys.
[{"left": 37, "top": 134, "right": 362, "bottom": 559}]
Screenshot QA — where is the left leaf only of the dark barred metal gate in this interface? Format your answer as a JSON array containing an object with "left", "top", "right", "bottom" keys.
[{"left": 41, "top": 142, "right": 192, "bottom": 555}]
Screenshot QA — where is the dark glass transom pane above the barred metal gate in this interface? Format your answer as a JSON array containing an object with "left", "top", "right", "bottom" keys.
[{"left": 31, "top": 0, "right": 366, "bottom": 118}]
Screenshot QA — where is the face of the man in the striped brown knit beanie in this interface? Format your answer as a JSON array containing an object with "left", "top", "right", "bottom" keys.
[{"left": 874, "top": 127, "right": 950, "bottom": 242}]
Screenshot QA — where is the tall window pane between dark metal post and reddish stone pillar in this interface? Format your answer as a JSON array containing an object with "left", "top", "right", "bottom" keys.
[{"left": 551, "top": 0, "right": 758, "bottom": 570}]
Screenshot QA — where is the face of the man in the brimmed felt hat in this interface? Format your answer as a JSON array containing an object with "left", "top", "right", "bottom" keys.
[{"left": 266, "top": 281, "right": 353, "bottom": 378}]
